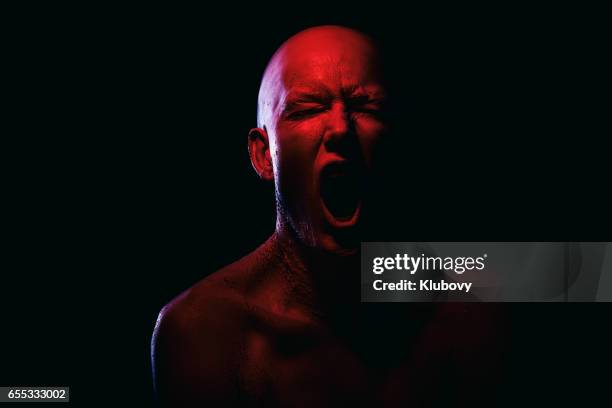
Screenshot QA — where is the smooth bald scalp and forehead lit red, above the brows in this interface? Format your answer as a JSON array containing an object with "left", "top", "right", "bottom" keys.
[{"left": 257, "top": 26, "right": 380, "bottom": 128}]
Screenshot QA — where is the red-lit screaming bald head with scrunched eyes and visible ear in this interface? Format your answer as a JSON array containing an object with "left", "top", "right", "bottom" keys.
[{"left": 249, "top": 26, "right": 386, "bottom": 254}]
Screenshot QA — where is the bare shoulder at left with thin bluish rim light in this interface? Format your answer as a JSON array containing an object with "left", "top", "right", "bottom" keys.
[{"left": 151, "top": 265, "right": 256, "bottom": 406}]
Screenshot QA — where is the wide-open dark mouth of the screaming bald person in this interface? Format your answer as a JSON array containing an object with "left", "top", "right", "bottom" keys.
[{"left": 320, "top": 162, "right": 363, "bottom": 224}]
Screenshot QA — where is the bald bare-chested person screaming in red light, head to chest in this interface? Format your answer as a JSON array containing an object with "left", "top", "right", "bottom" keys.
[{"left": 152, "top": 26, "right": 504, "bottom": 407}]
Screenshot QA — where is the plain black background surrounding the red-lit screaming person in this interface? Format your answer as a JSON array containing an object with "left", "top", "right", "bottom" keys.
[{"left": 0, "top": 5, "right": 611, "bottom": 406}]
